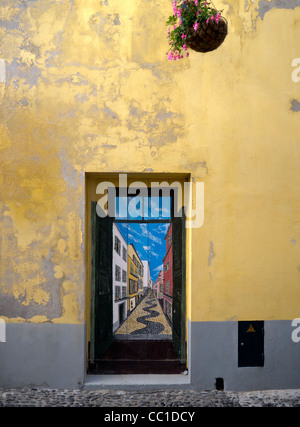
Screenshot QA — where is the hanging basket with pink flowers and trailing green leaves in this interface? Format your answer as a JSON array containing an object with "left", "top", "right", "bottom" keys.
[{"left": 166, "top": 0, "right": 228, "bottom": 60}]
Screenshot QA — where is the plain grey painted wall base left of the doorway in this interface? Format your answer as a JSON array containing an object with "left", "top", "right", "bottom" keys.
[{"left": 0, "top": 323, "right": 85, "bottom": 389}]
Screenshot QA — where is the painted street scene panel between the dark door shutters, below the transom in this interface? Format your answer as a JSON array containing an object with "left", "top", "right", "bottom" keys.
[{"left": 113, "top": 222, "right": 173, "bottom": 340}]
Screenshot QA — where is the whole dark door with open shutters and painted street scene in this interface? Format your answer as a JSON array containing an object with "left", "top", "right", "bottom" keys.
[{"left": 88, "top": 191, "right": 186, "bottom": 374}]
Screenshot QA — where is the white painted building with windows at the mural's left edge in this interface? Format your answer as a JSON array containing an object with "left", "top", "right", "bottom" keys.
[{"left": 112, "top": 223, "right": 127, "bottom": 332}]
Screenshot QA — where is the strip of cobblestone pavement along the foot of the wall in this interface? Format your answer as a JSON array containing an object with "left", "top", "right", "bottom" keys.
[{"left": 0, "top": 388, "right": 300, "bottom": 408}]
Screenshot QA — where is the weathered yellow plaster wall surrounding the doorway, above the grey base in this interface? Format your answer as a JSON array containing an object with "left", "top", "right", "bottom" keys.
[{"left": 0, "top": 0, "right": 300, "bottom": 323}]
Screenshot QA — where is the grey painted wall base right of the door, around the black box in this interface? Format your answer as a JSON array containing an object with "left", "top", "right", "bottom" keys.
[{"left": 189, "top": 320, "right": 300, "bottom": 391}]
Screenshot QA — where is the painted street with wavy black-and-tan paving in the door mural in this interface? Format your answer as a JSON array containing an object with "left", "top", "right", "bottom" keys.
[{"left": 116, "top": 295, "right": 172, "bottom": 339}]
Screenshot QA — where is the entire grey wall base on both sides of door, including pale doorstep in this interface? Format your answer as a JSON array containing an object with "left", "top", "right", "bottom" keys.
[{"left": 0, "top": 320, "right": 300, "bottom": 391}]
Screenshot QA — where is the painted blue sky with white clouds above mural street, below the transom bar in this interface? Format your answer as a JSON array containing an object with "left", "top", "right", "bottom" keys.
[{"left": 117, "top": 222, "right": 170, "bottom": 282}]
